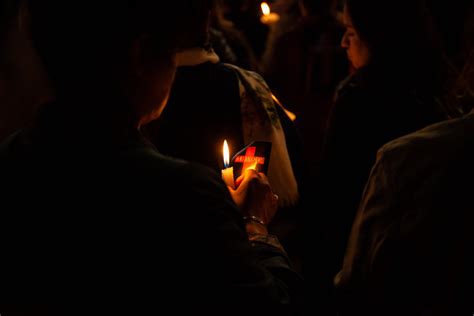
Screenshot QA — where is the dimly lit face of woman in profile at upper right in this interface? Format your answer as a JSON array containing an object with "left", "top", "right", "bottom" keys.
[{"left": 341, "top": 6, "right": 370, "bottom": 69}]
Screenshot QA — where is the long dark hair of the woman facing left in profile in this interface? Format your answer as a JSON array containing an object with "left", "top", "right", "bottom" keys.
[{"left": 345, "top": 0, "right": 446, "bottom": 94}]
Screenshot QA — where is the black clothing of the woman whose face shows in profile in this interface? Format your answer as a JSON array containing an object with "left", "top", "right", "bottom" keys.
[{"left": 311, "top": 70, "right": 446, "bottom": 314}]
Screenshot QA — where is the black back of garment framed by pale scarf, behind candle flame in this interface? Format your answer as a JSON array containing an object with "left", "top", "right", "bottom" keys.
[{"left": 146, "top": 62, "right": 245, "bottom": 171}]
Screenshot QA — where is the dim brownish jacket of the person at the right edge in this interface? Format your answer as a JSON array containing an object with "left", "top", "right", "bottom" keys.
[{"left": 336, "top": 113, "right": 474, "bottom": 315}]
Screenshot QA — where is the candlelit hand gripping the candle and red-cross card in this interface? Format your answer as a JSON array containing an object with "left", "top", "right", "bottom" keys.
[{"left": 229, "top": 169, "right": 278, "bottom": 225}]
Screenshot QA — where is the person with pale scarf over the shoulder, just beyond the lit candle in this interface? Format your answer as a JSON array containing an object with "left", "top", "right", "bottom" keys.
[{"left": 144, "top": 0, "right": 303, "bottom": 274}]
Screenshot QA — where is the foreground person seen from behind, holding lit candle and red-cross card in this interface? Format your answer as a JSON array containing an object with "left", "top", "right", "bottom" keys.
[{"left": 0, "top": 0, "right": 302, "bottom": 315}]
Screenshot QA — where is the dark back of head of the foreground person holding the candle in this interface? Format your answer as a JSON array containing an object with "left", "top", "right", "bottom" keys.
[{"left": 29, "top": 0, "right": 198, "bottom": 92}]
